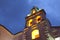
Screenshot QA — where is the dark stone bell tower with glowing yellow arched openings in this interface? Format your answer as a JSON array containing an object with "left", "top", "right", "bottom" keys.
[{"left": 24, "top": 7, "right": 51, "bottom": 40}]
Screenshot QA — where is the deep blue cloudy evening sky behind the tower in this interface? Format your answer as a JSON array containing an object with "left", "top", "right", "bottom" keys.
[{"left": 0, "top": 0, "right": 60, "bottom": 34}]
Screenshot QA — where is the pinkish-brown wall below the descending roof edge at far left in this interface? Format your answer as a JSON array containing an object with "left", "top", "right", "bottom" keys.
[{"left": 0, "top": 26, "right": 13, "bottom": 40}]
